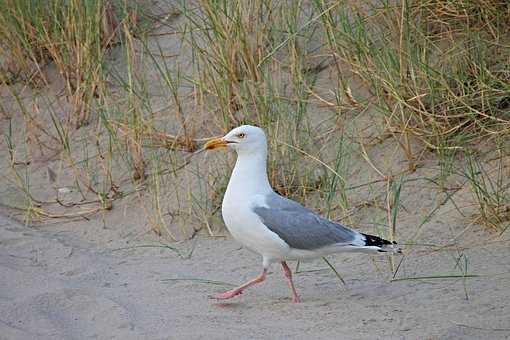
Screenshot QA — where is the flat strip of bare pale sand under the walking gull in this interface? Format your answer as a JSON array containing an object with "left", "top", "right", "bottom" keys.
[{"left": 0, "top": 211, "right": 510, "bottom": 339}]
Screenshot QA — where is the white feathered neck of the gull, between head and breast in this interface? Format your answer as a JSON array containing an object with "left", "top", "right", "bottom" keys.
[{"left": 225, "top": 150, "right": 273, "bottom": 199}]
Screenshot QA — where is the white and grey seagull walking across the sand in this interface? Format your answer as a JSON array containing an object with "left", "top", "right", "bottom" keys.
[{"left": 204, "top": 125, "right": 401, "bottom": 303}]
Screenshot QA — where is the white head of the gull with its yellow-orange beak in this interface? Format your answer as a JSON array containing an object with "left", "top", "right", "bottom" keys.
[{"left": 204, "top": 125, "right": 267, "bottom": 154}]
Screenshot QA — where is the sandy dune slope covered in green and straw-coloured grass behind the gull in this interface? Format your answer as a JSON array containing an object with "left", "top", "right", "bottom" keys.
[{"left": 0, "top": 0, "right": 510, "bottom": 247}]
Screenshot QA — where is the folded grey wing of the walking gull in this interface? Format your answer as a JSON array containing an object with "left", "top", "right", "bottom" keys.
[{"left": 253, "top": 193, "right": 359, "bottom": 250}]
